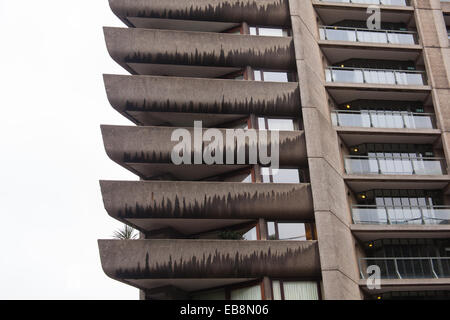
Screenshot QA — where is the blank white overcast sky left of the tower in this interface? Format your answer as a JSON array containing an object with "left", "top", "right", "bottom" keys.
[{"left": 0, "top": 0, "right": 138, "bottom": 299}]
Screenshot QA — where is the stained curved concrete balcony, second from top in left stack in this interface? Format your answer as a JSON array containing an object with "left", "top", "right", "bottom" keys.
[{"left": 104, "top": 28, "right": 296, "bottom": 78}]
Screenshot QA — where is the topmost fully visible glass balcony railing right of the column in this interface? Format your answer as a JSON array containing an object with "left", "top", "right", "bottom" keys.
[{"left": 319, "top": 26, "right": 419, "bottom": 44}]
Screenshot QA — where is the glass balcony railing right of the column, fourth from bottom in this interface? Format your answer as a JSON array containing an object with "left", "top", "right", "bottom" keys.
[{"left": 331, "top": 110, "right": 436, "bottom": 129}]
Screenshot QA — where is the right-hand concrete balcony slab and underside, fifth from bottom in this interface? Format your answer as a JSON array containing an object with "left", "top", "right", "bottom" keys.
[{"left": 325, "top": 83, "right": 431, "bottom": 105}]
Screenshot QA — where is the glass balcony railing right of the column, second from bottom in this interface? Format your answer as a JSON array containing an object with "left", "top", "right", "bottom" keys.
[{"left": 352, "top": 205, "right": 450, "bottom": 225}]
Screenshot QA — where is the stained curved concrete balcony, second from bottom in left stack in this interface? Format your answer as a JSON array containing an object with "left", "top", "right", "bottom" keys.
[{"left": 100, "top": 181, "right": 314, "bottom": 236}]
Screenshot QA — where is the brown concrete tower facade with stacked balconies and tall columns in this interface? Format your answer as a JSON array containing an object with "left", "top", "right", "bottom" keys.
[{"left": 99, "top": 0, "right": 450, "bottom": 300}]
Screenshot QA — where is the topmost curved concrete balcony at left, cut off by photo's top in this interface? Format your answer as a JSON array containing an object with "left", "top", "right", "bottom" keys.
[{"left": 109, "top": 0, "right": 291, "bottom": 27}]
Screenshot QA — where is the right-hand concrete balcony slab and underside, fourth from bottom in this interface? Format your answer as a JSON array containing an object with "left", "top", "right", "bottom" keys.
[{"left": 336, "top": 127, "right": 441, "bottom": 146}]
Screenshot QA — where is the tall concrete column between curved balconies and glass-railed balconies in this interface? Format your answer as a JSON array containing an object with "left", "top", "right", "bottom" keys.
[{"left": 289, "top": 0, "right": 362, "bottom": 300}]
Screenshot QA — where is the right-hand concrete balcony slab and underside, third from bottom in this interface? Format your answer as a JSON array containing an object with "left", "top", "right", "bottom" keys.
[{"left": 344, "top": 175, "right": 450, "bottom": 193}]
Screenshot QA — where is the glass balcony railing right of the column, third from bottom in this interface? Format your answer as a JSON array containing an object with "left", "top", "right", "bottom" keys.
[{"left": 345, "top": 154, "right": 446, "bottom": 175}]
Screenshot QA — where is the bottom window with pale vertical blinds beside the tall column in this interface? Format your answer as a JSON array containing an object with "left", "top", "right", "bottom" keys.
[{"left": 272, "top": 281, "right": 319, "bottom": 300}]
